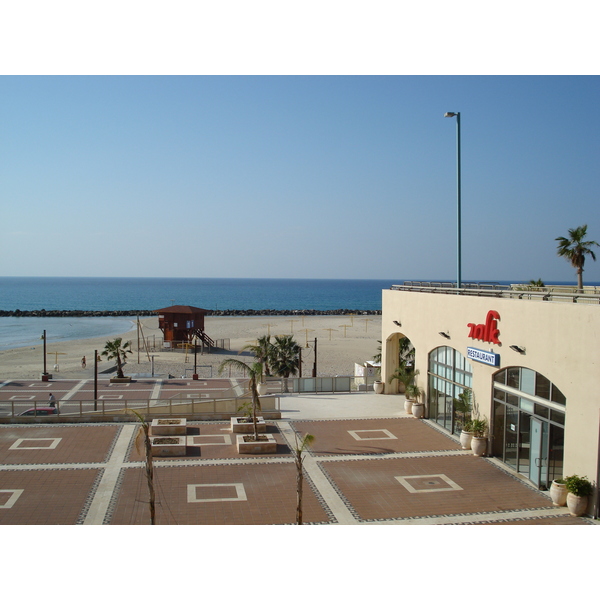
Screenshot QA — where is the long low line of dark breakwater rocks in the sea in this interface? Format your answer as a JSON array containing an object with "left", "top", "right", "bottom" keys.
[{"left": 0, "top": 308, "right": 381, "bottom": 317}]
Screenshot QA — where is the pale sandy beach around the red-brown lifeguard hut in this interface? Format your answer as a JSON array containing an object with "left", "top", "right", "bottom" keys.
[{"left": 0, "top": 315, "right": 381, "bottom": 380}]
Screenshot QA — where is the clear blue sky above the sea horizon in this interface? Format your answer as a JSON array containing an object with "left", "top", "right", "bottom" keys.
[{"left": 0, "top": 4, "right": 600, "bottom": 282}]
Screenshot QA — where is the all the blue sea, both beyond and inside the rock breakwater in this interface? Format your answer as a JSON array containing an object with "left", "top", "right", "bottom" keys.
[{"left": 0, "top": 277, "right": 592, "bottom": 350}]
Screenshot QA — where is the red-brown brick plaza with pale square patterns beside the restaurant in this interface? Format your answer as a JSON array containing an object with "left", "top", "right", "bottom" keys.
[{"left": 0, "top": 382, "right": 595, "bottom": 525}]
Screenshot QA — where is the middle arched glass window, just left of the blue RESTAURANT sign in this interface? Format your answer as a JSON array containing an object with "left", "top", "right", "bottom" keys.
[{"left": 427, "top": 346, "right": 473, "bottom": 435}]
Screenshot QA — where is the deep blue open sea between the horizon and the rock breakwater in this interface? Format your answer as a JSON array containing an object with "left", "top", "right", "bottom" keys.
[{"left": 0, "top": 277, "right": 399, "bottom": 310}]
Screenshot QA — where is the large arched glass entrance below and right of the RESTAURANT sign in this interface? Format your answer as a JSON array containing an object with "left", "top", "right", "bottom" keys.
[{"left": 492, "top": 367, "right": 567, "bottom": 489}]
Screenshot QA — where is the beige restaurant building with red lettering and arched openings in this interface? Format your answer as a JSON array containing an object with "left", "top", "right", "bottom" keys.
[{"left": 382, "top": 282, "right": 600, "bottom": 515}]
